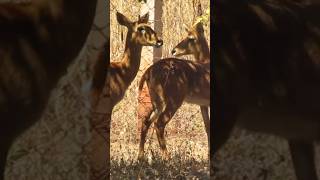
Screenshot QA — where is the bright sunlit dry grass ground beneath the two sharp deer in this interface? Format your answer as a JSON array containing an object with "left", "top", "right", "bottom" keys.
[{"left": 111, "top": 85, "right": 209, "bottom": 179}]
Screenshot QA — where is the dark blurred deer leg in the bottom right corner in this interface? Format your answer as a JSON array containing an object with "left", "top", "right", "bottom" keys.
[{"left": 289, "top": 140, "right": 318, "bottom": 180}]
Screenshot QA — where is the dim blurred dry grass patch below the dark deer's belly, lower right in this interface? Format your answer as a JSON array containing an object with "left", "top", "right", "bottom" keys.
[{"left": 213, "top": 129, "right": 295, "bottom": 180}]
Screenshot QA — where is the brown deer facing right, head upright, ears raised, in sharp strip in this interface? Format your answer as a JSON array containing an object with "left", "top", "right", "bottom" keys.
[{"left": 91, "top": 12, "right": 163, "bottom": 109}]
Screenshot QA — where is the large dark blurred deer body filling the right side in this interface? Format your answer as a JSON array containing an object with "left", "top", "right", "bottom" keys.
[{"left": 214, "top": 0, "right": 320, "bottom": 180}]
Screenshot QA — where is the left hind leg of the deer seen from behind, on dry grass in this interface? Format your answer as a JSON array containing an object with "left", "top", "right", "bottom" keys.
[{"left": 138, "top": 108, "right": 158, "bottom": 160}]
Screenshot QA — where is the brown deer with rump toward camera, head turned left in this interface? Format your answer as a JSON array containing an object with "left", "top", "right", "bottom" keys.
[{"left": 138, "top": 22, "right": 210, "bottom": 160}]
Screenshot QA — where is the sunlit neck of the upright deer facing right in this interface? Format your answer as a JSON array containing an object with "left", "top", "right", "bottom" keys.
[{"left": 122, "top": 36, "right": 142, "bottom": 85}]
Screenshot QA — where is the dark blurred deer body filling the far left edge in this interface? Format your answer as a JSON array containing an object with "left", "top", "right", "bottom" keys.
[{"left": 0, "top": 0, "right": 97, "bottom": 180}]
